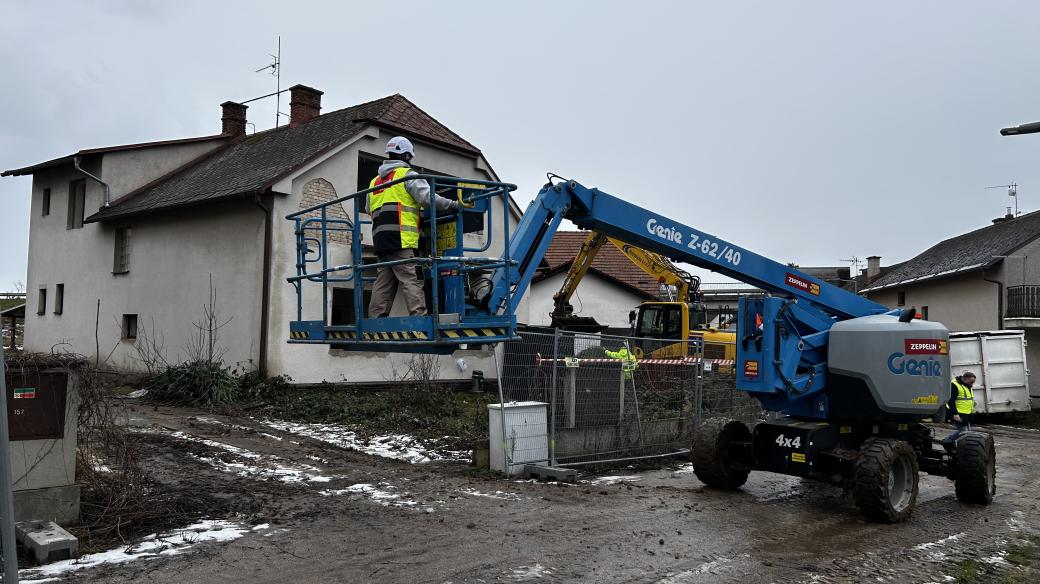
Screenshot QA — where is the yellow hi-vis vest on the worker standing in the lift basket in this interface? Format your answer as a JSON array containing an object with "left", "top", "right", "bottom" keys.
[{"left": 368, "top": 166, "right": 419, "bottom": 251}]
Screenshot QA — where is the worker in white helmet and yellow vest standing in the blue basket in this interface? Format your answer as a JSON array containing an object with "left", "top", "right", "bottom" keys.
[{"left": 368, "top": 136, "right": 459, "bottom": 318}]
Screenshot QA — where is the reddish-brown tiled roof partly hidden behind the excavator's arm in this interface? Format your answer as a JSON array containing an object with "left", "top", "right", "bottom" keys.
[{"left": 536, "top": 231, "right": 659, "bottom": 298}]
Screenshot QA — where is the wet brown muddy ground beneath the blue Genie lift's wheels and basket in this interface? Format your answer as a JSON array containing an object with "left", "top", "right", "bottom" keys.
[{"left": 42, "top": 406, "right": 1040, "bottom": 584}]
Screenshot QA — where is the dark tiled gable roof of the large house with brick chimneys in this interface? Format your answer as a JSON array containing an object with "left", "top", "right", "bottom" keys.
[{"left": 86, "top": 95, "right": 479, "bottom": 221}]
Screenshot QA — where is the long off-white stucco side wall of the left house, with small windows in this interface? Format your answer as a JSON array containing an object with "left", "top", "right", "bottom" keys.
[{"left": 25, "top": 152, "right": 263, "bottom": 369}]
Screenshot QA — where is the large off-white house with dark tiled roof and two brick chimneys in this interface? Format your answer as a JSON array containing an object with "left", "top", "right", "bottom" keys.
[{"left": 3, "top": 85, "right": 526, "bottom": 382}]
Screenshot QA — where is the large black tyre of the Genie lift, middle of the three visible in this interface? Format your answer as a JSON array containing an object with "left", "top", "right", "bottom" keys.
[{"left": 852, "top": 439, "right": 919, "bottom": 523}]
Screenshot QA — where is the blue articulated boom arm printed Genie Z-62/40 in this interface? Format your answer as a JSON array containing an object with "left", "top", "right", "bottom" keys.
[{"left": 487, "top": 181, "right": 889, "bottom": 419}]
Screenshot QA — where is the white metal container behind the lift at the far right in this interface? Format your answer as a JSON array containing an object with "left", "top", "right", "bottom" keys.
[{"left": 950, "top": 330, "right": 1030, "bottom": 414}]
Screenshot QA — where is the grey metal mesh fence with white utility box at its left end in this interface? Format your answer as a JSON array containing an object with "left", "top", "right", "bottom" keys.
[{"left": 492, "top": 331, "right": 764, "bottom": 466}]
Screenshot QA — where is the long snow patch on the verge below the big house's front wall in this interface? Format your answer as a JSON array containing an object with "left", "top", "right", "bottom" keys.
[{"left": 261, "top": 420, "right": 465, "bottom": 463}]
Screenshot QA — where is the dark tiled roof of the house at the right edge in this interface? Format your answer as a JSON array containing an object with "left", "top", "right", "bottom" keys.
[{"left": 863, "top": 211, "right": 1040, "bottom": 292}]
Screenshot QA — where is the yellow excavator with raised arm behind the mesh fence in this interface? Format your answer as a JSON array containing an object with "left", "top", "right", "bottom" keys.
[{"left": 549, "top": 232, "right": 736, "bottom": 360}]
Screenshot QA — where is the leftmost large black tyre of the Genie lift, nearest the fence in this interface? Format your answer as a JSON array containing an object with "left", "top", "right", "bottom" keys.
[{"left": 691, "top": 418, "right": 752, "bottom": 489}]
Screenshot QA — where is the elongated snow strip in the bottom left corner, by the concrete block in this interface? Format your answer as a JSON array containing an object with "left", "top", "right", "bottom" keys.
[{"left": 19, "top": 520, "right": 256, "bottom": 584}]
